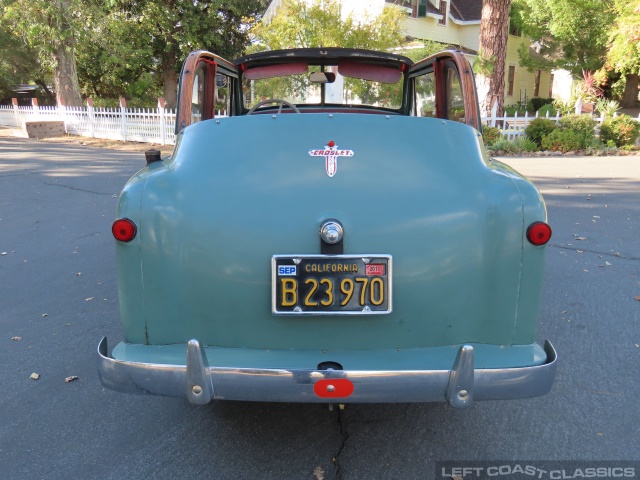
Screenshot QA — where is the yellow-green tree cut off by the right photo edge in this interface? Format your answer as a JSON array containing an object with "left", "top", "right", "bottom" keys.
[{"left": 605, "top": 0, "right": 640, "bottom": 108}]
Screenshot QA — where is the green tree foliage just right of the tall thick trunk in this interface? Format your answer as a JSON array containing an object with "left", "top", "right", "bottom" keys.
[{"left": 511, "top": 0, "right": 615, "bottom": 77}]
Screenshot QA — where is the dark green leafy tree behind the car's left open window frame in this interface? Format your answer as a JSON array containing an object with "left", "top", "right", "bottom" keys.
[{"left": 94, "top": 0, "right": 266, "bottom": 106}]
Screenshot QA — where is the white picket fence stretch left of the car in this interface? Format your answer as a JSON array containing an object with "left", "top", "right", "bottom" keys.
[{"left": 0, "top": 105, "right": 176, "bottom": 145}]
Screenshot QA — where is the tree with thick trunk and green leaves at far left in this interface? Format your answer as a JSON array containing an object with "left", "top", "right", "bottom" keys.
[{"left": 0, "top": 0, "right": 88, "bottom": 106}]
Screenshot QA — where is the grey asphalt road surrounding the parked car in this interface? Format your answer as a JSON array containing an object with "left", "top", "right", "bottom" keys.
[{"left": 0, "top": 138, "right": 640, "bottom": 480}]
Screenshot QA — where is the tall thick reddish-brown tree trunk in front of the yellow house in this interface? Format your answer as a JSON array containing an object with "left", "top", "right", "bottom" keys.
[{"left": 477, "top": 0, "right": 511, "bottom": 116}]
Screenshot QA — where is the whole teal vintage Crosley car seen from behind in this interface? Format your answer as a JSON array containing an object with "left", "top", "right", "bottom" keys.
[{"left": 98, "top": 49, "right": 556, "bottom": 407}]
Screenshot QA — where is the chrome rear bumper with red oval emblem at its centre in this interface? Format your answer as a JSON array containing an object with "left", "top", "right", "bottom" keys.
[{"left": 98, "top": 337, "right": 557, "bottom": 408}]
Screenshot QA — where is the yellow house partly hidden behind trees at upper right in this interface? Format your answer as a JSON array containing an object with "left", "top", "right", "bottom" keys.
[{"left": 386, "top": 0, "right": 553, "bottom": 106}]
